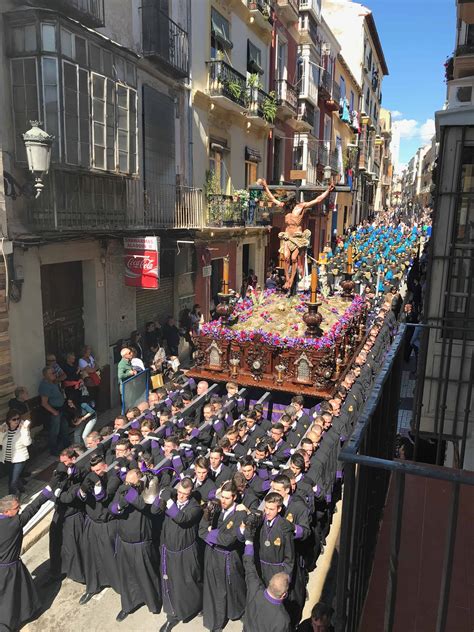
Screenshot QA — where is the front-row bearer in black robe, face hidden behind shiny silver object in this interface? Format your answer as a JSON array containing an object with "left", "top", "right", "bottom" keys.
[{"left": 110, "top": 485, "right": 161, "bottom": 614}]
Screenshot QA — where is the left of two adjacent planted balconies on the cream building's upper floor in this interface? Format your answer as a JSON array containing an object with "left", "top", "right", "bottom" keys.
[{"left": 207, "top": 59, "right": 248, "bottom": 112}]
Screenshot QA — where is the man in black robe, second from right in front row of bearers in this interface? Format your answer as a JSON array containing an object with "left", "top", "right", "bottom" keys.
[{"left": 199, "top": 505, "right": 247, "bottom": 630}]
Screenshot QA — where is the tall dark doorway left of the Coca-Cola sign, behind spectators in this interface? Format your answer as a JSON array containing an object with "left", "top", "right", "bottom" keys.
[{"left": 41, "top": 261, "right": 84, "bottom": 360}]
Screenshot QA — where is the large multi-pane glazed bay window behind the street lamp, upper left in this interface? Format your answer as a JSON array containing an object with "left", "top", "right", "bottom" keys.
[{"left": 8, "top": 21, "right": 137, "bottom": 173}]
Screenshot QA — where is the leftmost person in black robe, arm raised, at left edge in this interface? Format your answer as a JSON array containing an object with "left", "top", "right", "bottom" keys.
[{"left": 0, "top": 494, "right": 47, "bottom": 630}]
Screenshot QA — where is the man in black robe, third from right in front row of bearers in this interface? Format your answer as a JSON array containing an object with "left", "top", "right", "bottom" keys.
[{"left": 156, "top": 498, "right": 202, "bottom": 621}]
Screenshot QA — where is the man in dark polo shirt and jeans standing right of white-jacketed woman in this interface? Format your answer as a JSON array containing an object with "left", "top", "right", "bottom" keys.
[{"left": 38, "top": 366, "right": 69, "bottom": 456}]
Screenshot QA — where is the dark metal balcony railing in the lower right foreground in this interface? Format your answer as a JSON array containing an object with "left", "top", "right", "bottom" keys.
[{"left": 336, "top": 325, "right": 474, "bottom": 632}]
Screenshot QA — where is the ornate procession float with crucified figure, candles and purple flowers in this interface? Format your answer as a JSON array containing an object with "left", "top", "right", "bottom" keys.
[{"left": 189, "top": 175, "right": 367, "bottom": 399}]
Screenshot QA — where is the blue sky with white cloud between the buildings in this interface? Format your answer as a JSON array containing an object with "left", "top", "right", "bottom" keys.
[{"left": 361, "top": 0, "right": 456, "bottom": 168}]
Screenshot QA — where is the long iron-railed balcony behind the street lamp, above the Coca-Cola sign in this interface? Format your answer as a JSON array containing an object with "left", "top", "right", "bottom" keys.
[{"left": 26, "top": 170, "right": 204, "bottom": 233}]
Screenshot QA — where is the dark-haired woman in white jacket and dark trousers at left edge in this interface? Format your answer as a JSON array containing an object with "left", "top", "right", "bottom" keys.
[{"left": 0, "top": 410, "right": 31, "bottom": 495}]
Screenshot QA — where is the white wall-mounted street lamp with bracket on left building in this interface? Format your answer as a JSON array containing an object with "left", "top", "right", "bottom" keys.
[{"left": 3, "top": 121, "right": 54, "bottom": 200}]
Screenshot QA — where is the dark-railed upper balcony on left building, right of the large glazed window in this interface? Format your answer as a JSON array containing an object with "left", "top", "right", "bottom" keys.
[{"left": 142, "top": 3, "right": 189, "bottom": 79}]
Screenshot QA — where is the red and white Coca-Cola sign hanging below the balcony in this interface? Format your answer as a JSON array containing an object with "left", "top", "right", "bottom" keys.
[{"left": 123, "top": 237, "right": 160, "bottom": 290}]
